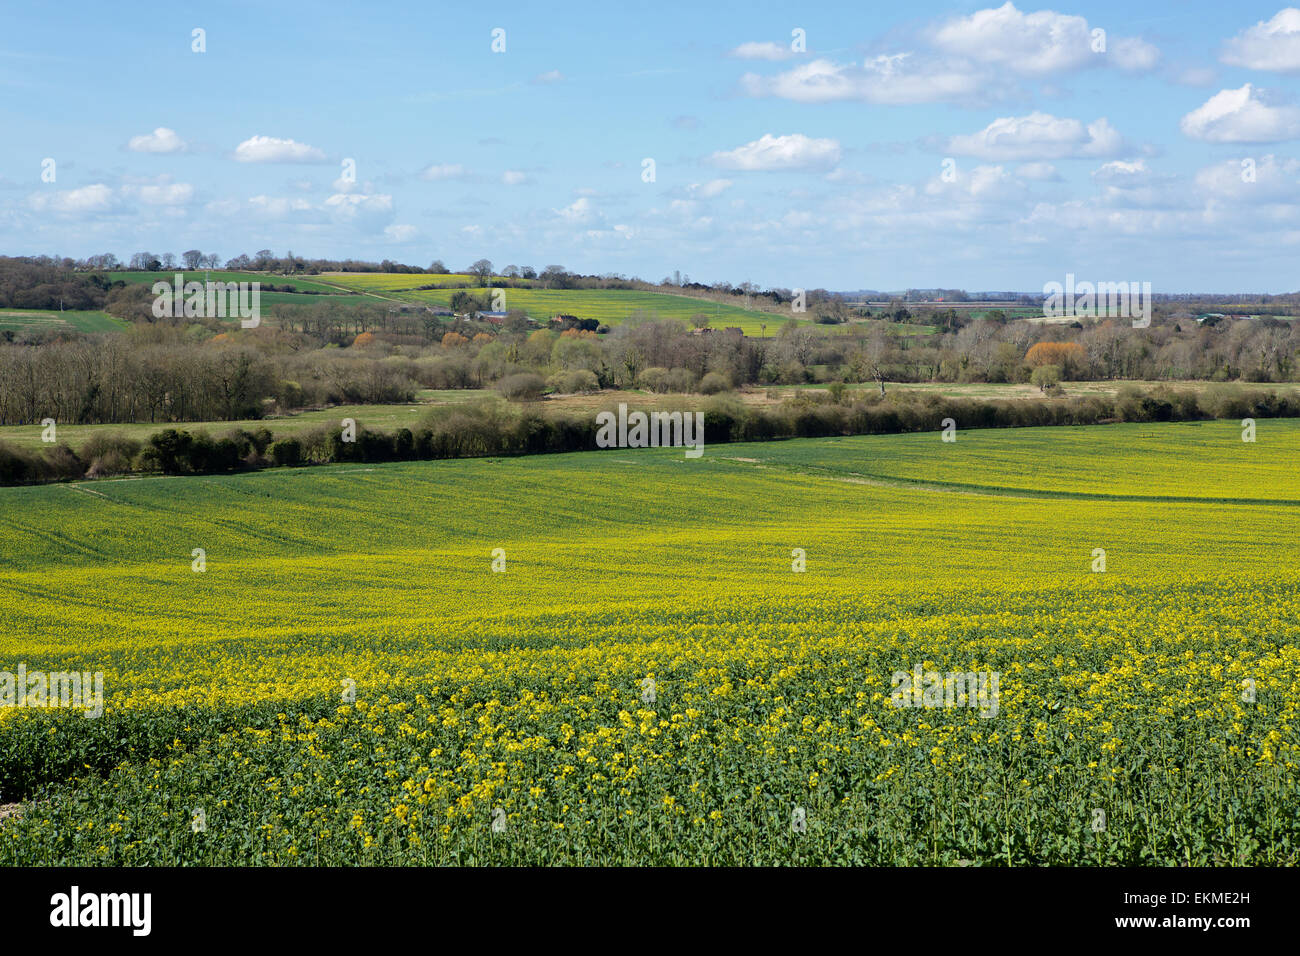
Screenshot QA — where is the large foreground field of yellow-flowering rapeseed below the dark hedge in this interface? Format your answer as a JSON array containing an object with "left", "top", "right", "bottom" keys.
[{"left": 0, "top": 420, "right": 1300, "bottom": 865}]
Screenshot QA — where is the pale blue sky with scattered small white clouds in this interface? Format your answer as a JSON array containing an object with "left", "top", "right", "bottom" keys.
[{"left": 0, "top": 0, "right": 1300, "bottom": 293}]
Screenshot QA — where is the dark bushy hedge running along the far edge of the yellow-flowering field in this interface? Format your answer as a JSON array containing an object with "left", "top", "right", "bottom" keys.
[{"left": 0, "top": 388, "right": 1300, "bottom": 485}]
